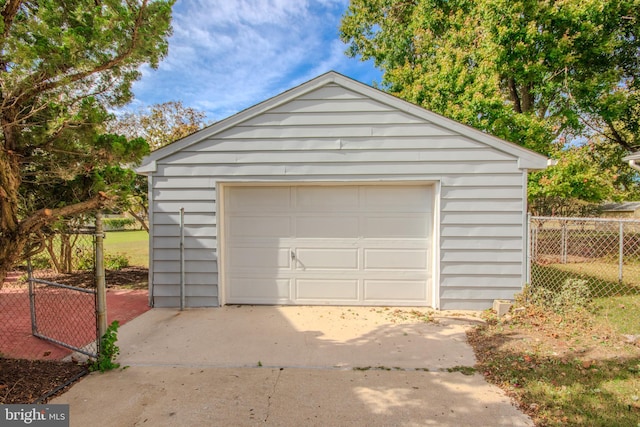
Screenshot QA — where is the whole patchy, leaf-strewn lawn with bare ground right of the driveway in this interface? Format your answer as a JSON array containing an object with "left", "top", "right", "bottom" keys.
[{"left": 468, "top": 286, "right": 640, "bottom": 427}]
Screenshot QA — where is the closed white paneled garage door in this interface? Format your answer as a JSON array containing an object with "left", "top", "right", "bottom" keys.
[{"left": 223, "top": 185, "right": 433, "bottom": 305}]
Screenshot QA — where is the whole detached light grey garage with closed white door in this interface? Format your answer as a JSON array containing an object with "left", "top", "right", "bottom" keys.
[{"left": 137, "top": 72, "right": 547, "bottom": 309}]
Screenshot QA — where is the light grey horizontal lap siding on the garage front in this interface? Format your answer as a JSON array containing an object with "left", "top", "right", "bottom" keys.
[{"left": 152, "top": 85, "right": 523, "bottom": 309}]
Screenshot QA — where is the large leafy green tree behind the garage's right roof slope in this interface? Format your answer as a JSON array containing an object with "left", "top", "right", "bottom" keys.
[{"left": 340, "top": 0, "right": 640, "bottom": 155}]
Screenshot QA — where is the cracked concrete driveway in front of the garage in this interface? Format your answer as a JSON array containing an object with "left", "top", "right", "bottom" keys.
[{"left": 51, "top": 306, "right": 533, "bottom": 426}]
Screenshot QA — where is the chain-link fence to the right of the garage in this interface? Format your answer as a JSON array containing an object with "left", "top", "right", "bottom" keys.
[{"left": 529, "top": 217, "right": 640, "bottom": 298}]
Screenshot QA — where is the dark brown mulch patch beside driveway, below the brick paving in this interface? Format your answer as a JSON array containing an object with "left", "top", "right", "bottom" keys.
[{"left": 0, "top": 358, "right": 87, "bottom": 404}]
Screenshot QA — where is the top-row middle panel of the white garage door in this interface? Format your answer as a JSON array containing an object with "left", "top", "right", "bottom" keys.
[{"left": 296, "top": 186, "right": 359, "bottom": 212}]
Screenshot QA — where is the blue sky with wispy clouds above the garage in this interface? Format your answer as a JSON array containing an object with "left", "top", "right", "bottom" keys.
[{"left": 129, "top": 0, "right": 381, "bottom": 122}]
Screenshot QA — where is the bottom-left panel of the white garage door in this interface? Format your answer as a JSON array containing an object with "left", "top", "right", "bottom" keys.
[{"left": 229, "top": 277, "right": 291, "bottom": 304}]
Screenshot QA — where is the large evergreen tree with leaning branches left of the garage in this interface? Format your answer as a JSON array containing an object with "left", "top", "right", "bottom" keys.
[{"left": 0, "top": 0, "right": 174, "bottom": 280}]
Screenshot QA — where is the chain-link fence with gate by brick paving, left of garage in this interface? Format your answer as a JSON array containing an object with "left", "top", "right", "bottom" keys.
[{"left": 0, "top": 224, "right": 99, "bottom": 360}]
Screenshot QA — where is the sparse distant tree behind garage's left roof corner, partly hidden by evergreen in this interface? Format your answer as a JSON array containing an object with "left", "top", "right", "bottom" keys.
[{"left": 108, "top": 101, "right": 206, "bottom": 232}]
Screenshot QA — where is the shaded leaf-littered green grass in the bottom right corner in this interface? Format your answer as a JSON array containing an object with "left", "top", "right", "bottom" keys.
[{"left": 484, "top": 353, "right": 640, "bottom": 427}]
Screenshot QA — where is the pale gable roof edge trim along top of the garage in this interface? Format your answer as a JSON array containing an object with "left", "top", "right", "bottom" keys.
[{"left": 136, "top": 71, "right": 549, "bottom": 174}]
